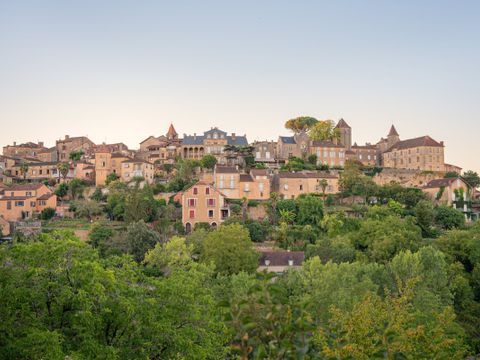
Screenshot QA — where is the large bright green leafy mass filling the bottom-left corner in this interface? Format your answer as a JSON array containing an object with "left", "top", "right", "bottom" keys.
[{"left": 0, "top": 234, "right": 228, "bottom": 359}]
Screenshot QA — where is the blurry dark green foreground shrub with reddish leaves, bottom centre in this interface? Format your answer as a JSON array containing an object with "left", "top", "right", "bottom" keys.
[{"left": 225, "top": 274, "right": 314, "bottom": 359}]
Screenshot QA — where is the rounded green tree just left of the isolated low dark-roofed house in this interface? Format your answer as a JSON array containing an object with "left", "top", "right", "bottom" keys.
[{"left": 201, "top": 224, "right": 259, "bottom": 275}]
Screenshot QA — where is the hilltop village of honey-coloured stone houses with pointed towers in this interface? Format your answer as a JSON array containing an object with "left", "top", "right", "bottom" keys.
[{"left": 0, "top": 117, "right": 478, "bottom": 234}]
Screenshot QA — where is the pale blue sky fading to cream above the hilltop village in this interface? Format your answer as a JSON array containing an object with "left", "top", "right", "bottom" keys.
[{"left": 0, "top": 0, "right": 480, "bottom": 171}]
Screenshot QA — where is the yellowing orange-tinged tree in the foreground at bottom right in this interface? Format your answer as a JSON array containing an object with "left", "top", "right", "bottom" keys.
[{"left": 314, "top": 287, "right": 466, "bottom": 359}]
